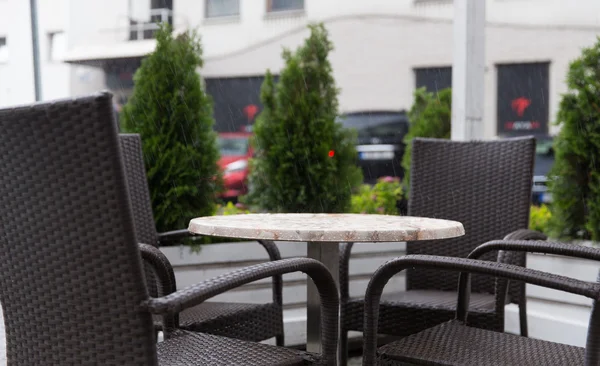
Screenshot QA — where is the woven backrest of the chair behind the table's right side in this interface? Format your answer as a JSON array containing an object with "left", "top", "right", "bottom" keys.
[{"left": 406, "top": 137, "right": 535, "bottom": 293}]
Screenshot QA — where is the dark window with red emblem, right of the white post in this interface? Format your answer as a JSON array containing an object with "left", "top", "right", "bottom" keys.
[{"left": 497, "top": 63, "right": 549, "bottom": 136}]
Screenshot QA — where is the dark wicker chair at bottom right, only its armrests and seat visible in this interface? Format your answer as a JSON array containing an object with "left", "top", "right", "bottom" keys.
[{"left": 363, "top": 241, "right": 600, "bottom": 366}]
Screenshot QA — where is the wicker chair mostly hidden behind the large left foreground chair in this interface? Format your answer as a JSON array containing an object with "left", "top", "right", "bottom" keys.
[{"left": 119, "top": 134, "right": 284, "bottom": 346}]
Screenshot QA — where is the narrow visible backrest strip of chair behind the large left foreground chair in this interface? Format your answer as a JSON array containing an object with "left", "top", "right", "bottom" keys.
[{"left": 119, "top": 134, "right": 158, "bottom": 247}]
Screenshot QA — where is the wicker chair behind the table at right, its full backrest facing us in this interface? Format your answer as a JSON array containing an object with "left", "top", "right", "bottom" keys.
[{"left": 340, "top": 138, "right": 546, "bottom": 364}]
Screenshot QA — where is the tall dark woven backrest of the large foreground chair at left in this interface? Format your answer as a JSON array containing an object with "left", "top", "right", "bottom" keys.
[{"left": 0, "top": 93, "right": 156, "bottom": 365}]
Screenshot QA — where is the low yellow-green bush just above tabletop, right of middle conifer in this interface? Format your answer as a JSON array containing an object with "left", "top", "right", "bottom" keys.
[{"left": 351, "top": 177, "right": 402, "bottom": 215}]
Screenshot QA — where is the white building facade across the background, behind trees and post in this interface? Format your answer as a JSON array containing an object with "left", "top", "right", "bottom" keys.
[{"left": 0, "top": 0, "right": 600, "bottom": 138}]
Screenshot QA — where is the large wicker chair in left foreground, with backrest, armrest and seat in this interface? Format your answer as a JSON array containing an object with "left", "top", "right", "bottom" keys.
[{"left": 0, "top": 93, "right": 339, "bottom": 366}]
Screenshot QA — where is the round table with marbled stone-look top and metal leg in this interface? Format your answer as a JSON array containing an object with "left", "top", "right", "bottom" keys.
[{"left": 188, "top": 214, "right": 465, "bottom": 352}]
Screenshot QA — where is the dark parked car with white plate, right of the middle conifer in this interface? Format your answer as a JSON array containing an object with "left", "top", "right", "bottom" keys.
[{"left": 340, "top": 111, "right": 408, "bottom": 183}]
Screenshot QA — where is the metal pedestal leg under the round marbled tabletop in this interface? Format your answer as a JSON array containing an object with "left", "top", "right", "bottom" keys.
[{"left": 306, "top": 242, "right": 340, "bottom": 353}]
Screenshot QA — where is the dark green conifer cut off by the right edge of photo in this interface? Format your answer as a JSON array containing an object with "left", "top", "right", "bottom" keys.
[{"left": 549, "top": 38, "right": 600, "bottom": 240}]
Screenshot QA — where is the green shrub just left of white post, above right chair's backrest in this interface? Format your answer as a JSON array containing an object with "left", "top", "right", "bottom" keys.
[{"left": 402, "top": 88, "right": 452, "bottom": 190}]
